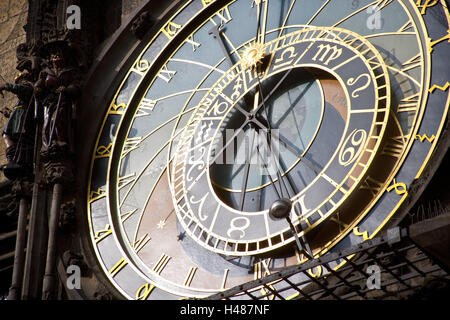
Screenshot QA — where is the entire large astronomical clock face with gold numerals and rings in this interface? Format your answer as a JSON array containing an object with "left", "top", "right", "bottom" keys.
[{"left": 87, "top": 0, "right": 450, "bottom": 299}]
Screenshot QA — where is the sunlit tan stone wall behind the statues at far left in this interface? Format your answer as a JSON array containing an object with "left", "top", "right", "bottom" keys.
[{"left": 0, "top": 0, "right": 28, "bottom": 181}]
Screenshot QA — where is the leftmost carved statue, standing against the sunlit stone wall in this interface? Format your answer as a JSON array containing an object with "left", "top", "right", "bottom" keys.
[{"left": 0, "top": 70, "right": 35, "bottom": 180}]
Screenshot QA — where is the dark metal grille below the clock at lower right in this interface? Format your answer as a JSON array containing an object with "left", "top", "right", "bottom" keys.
[{"left": 206, "top": 228, "right": 450, "bottom": 300}]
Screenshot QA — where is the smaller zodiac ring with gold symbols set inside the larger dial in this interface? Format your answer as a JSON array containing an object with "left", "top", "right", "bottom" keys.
[{"left": 170, "top": 27, "right": 390, "bottom": 255}]
